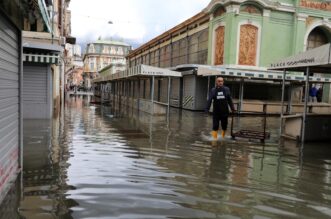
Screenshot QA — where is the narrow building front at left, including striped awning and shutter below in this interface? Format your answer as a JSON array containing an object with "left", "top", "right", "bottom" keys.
[{"left": 23, "top": 0, "right": 71, "bottom": 119}]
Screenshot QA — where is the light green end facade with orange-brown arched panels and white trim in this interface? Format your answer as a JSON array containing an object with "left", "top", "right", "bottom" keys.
[{"left": 205, "top": 0, "right": 331, "bottom": 101}]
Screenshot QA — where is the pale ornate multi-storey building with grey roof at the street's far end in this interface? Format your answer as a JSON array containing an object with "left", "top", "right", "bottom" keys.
[{"left": 83, "top": 40, "right": 132, "bottom": 88}]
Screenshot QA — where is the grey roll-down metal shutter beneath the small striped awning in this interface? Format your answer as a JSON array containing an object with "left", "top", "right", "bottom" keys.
[{"left": 23, "top": 64, "right": 51, "bottom": 119}]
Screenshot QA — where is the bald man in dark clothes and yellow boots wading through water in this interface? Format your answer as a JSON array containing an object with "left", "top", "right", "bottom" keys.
[{"left": 205, "top": 77, "right": 235, "bottom": 139}]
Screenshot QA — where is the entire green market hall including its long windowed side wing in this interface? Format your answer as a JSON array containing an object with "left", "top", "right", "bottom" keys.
[{"left": 128, "top": 0, "right": 331, "bottom": 102}]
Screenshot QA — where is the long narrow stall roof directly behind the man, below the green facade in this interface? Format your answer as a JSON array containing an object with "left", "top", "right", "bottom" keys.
[{"left": 197, "top": 65, "right": 331, "bottom": 83}]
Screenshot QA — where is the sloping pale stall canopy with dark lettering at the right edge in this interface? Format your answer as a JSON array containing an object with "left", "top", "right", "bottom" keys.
[{"left": 269, "top": 43, "right": 331, "bottom": 74}]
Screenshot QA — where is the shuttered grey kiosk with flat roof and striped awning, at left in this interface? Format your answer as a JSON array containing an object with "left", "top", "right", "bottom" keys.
[{"left": 23, "top": 43, "right": 61, "bottom": 119}]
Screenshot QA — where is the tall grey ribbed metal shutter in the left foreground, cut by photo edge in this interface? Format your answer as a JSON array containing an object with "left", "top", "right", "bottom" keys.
[{"left": 0, "top": 14, "right": 21, "bottom": 199}]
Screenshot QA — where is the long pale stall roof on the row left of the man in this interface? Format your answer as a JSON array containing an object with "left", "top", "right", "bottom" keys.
[{"left": 93, "top": 65, "right": 182, "bottom": 83}]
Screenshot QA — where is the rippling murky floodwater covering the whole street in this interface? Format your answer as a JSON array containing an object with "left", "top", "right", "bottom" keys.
[{"left": 0, "top": 98, "right": 331, "bottom": 219}]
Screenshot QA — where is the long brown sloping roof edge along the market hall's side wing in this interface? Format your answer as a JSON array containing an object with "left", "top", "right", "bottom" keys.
[{"left": 128, "top": 11, "right": 209, "bottom": 57}]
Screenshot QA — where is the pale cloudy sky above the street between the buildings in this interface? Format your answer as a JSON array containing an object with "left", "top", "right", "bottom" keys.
[{"left": 69, "top": 0, "right": 211, "bottom": 48}]
